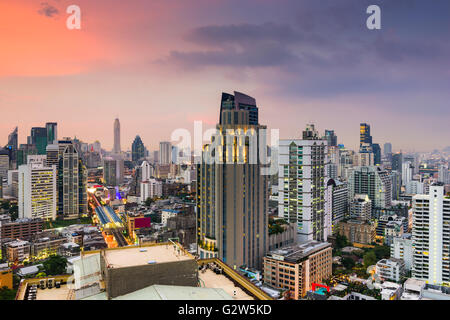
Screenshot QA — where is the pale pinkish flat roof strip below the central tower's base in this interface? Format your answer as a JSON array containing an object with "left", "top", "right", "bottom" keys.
[{"left": 198, "top": 269, "right": 254, "bottom": 300}]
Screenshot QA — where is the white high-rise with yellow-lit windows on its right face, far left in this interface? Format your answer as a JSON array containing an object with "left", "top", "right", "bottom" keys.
[{"left": 18, "top": 155, "right": 58, "bottom": 220}]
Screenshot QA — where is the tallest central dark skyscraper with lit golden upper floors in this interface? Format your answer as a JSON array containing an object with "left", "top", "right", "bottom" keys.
[{"left": 197, "top": 93, "right": 269, "bottom": 268}]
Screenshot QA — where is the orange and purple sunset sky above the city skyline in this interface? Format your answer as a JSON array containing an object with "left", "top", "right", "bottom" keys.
[{"left": 0, "top": 0, "right": 450, "bottom": 151}]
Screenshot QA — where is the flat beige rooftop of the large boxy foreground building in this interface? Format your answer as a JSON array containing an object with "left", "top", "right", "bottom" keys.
[{"left": 104, "top": 244, "right": 194, "bottom": 268}]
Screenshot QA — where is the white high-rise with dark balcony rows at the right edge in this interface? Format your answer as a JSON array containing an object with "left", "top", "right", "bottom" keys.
[{"left": 412, "top": 183, "right": 450, "bottom": 285}]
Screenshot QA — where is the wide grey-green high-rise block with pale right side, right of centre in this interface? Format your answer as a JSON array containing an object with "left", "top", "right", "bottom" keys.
[{"left": 349, "top": 166, "right": 392, "bottom": 210}]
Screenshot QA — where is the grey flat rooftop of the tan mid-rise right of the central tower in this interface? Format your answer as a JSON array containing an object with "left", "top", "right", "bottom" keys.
[{"left": 267, "top": 241, "right": 331, "bottom": 262}]
